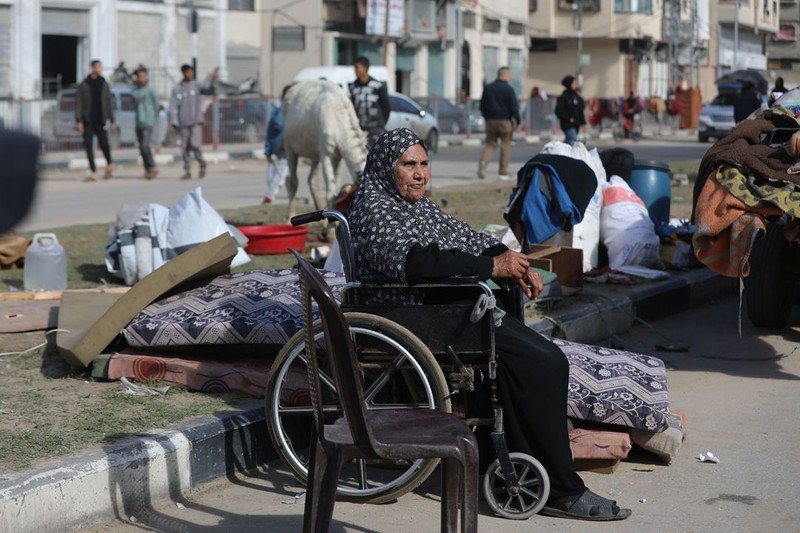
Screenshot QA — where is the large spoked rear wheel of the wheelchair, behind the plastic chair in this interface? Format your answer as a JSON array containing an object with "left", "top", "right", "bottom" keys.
[{"left": 265, "top": 313, "right": 451, "bottom": 503}]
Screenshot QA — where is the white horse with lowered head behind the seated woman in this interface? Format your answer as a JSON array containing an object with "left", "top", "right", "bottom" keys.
[{"left": 283, "top": 80, "right": 367, "bottom": 218}]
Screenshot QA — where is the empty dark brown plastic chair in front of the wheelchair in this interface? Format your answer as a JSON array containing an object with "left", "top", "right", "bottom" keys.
[{"left": 292, "top": 251, "right": 478, "bottom": 532}]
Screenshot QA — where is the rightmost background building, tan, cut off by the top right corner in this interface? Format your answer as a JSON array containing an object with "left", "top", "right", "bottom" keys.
[{"left": 767, "top": 0, "right": 800, "bottom": 88}]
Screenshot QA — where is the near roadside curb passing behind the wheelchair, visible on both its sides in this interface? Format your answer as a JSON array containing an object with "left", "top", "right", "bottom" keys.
[{"left": 0, "top": 269, "right": 735, "bottom": 533}]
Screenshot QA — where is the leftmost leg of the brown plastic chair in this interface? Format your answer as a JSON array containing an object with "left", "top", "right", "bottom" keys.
[{"left": 303, "top": 442, "right": 342, "bottom": 533}]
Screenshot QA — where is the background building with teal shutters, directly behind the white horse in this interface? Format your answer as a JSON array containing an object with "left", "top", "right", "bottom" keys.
[{"left": 256, "top": 0, "right": 527, "bottom": 99}]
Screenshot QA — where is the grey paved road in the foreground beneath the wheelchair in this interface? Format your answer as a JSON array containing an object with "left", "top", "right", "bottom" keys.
[{"left": 79, "top": 296, "right": 800, "bottom": 533}]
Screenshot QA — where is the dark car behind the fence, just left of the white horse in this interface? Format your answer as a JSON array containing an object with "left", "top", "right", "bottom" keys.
[{"left": 203, "top": 94, "right": 270, "bottom": 143}]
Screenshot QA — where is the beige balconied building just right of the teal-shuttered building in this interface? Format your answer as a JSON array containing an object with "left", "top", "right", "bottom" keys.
[{"left": 528, "top": 0, "right": 687, "bottom": 97}]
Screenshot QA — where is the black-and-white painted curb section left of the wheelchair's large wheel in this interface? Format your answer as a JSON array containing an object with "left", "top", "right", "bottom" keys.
[{"left": 0, "top": 401, "right": 277, "bottom": 533}]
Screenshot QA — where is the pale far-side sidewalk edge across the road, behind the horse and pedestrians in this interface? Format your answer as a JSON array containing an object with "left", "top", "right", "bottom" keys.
[{"left": 39, "top": 128, "right": 697, "bottom": 170}]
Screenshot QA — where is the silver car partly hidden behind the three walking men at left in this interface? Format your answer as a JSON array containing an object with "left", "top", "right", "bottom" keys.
[{"left": 53, "top": 85, "right": 174, "bottom": 149}]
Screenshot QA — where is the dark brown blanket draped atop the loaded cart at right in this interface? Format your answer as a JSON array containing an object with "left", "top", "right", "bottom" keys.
[{"left": 692, "top": 109, "right": 800, "bottom": 221}]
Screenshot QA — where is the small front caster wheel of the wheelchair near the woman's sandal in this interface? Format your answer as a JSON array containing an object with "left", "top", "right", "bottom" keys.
[{"left": 483, "top": 452, "right": 550, "bottom": 520}]
